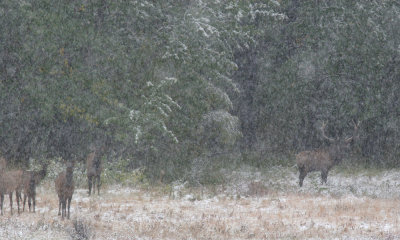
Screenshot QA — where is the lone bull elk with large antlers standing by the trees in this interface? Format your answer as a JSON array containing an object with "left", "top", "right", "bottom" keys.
[{"left": 296, "top": 122, "right": 360, "bottom": 187}]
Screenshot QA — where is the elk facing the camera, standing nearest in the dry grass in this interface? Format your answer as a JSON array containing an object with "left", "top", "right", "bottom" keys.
[{"left": 55, "top": 161, "right": 75, "bottom": 220}]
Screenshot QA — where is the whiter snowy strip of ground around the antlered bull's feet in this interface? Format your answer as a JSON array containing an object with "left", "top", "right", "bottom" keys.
[{"left": 226, "top": 167, "right": 400, "bottom": 198}]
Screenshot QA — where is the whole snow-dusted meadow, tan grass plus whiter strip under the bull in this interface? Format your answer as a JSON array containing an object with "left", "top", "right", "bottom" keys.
[{"left": 0, "top": 167, "right": 400, "bottom": 239}]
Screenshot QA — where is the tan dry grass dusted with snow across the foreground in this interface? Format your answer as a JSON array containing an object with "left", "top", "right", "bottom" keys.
[{"left": 0, "top": 181, "right": 400, "bottom": 239}]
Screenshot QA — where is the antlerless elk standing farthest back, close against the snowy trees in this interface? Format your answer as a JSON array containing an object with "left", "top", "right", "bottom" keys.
[{"left": 86, "top": 146, "right": 104, "bottom": 196}]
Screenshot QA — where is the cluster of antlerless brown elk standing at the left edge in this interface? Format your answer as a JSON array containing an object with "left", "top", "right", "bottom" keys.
[{"left": 0, "top": 147, "right": 104, "bottom": 219}]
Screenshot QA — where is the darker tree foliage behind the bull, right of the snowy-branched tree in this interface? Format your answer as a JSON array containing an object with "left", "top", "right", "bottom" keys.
[{"left": 245, "top": 1, "right": 400, "bottom": 166}]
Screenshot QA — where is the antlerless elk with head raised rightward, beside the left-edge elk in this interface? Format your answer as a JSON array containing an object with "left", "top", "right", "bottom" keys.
[{"left": 22, "top": 164, "right": 47, "bottom": 212}]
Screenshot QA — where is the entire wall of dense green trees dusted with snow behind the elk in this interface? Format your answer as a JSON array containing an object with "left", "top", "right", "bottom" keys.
[{"left": 0, "top": 0, "right": 400, "bottom": 179}]
